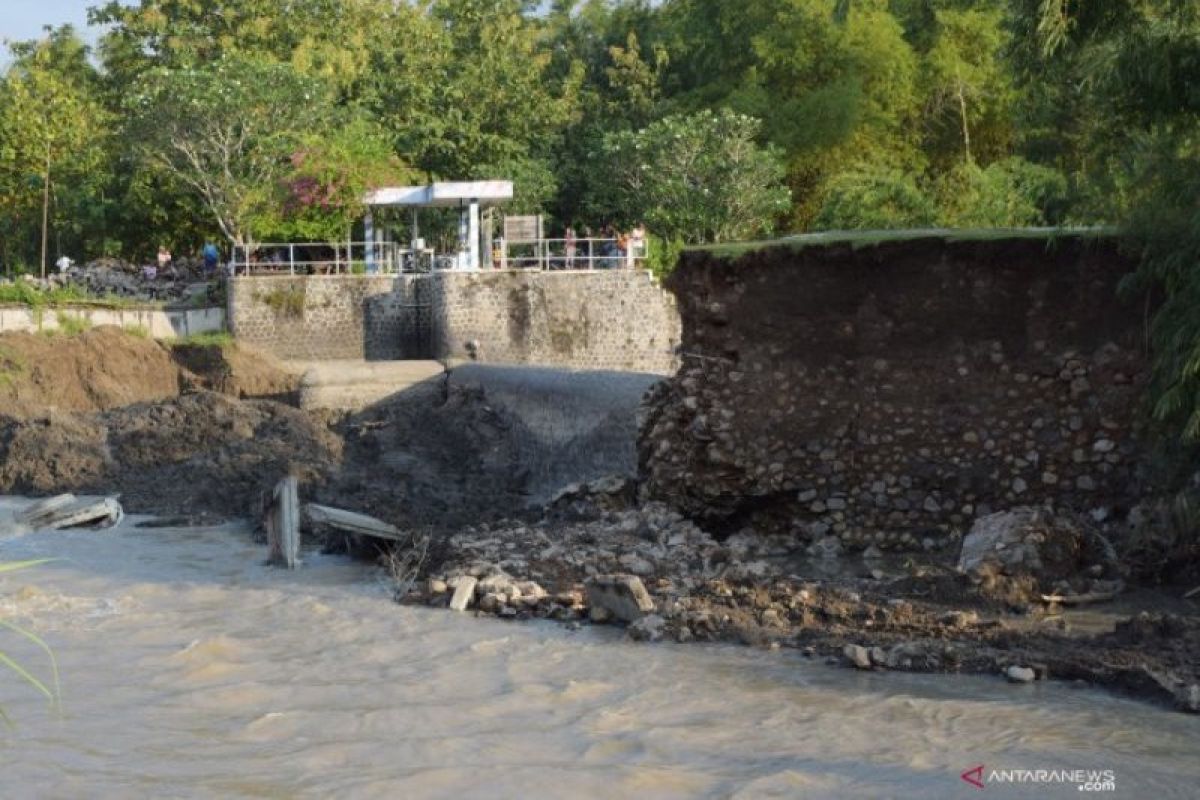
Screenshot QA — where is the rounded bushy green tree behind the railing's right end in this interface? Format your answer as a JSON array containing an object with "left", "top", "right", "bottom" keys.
[{"left": 604, "top": 110, "right": 791, "bottom": 243}]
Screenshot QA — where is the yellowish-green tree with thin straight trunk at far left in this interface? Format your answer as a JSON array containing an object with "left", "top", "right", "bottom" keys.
[{"left": 0, "top": 28, "right": 107, "bottom": 277}]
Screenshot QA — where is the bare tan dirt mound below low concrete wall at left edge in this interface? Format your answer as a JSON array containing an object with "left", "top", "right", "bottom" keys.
[{"left": 0, "top": 326, "right": 180, "bottom": 419}]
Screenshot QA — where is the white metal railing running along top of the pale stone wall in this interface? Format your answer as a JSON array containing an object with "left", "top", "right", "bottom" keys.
[{"left": 229, "top": 237, "right": 648, "bottom": 275}]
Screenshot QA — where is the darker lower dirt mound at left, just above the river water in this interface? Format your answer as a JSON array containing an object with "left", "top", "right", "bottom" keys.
[{"left": 0, "top": 392, "right": 342, "bottom": 516}]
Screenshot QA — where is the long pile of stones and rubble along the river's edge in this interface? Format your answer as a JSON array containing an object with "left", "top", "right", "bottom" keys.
[{"left": 397, "top": 480, "right": 1200, "bottom": 712}]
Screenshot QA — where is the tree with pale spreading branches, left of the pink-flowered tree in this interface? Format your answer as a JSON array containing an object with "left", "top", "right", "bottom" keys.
[{"left": 128, "top": 58, "right": 332, "bottom": 245}]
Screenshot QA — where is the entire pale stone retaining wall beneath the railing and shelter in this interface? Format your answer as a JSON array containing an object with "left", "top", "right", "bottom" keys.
[{"left": 229, "top": 270, "right": 679, "bottom": 374}]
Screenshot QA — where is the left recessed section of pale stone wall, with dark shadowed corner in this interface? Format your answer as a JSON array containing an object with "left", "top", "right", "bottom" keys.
[{"left": 229, "top": 275, "right": 430, "bottom": 361}]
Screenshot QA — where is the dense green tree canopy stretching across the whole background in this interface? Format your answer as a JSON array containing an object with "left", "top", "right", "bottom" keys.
[{"left": 0, "top": 0, "right": 1113, "bottom": 265}]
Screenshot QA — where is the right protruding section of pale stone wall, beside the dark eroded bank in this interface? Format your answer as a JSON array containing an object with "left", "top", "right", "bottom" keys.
[{"left": 430, "top": 270, "right": 679, "bottom": 374}]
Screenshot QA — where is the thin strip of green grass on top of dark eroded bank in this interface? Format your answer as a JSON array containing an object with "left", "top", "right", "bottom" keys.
[{"left": 686, "top": 228, "right": 1116, "bottom": 258}]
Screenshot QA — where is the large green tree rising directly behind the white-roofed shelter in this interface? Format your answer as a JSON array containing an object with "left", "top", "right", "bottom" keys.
[{"left": 365, "top": 0, "right": 582, "bottom": 211}]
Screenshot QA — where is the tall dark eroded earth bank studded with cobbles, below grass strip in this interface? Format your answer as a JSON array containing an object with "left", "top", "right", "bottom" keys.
[{"left": 640, "top": 237, "right": 1147, "bottom": 548}]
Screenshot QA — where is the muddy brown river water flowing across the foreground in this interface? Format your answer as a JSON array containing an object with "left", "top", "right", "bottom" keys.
[{"left": 0, "top": 510, "right": 1200, "bottom": 800}]
